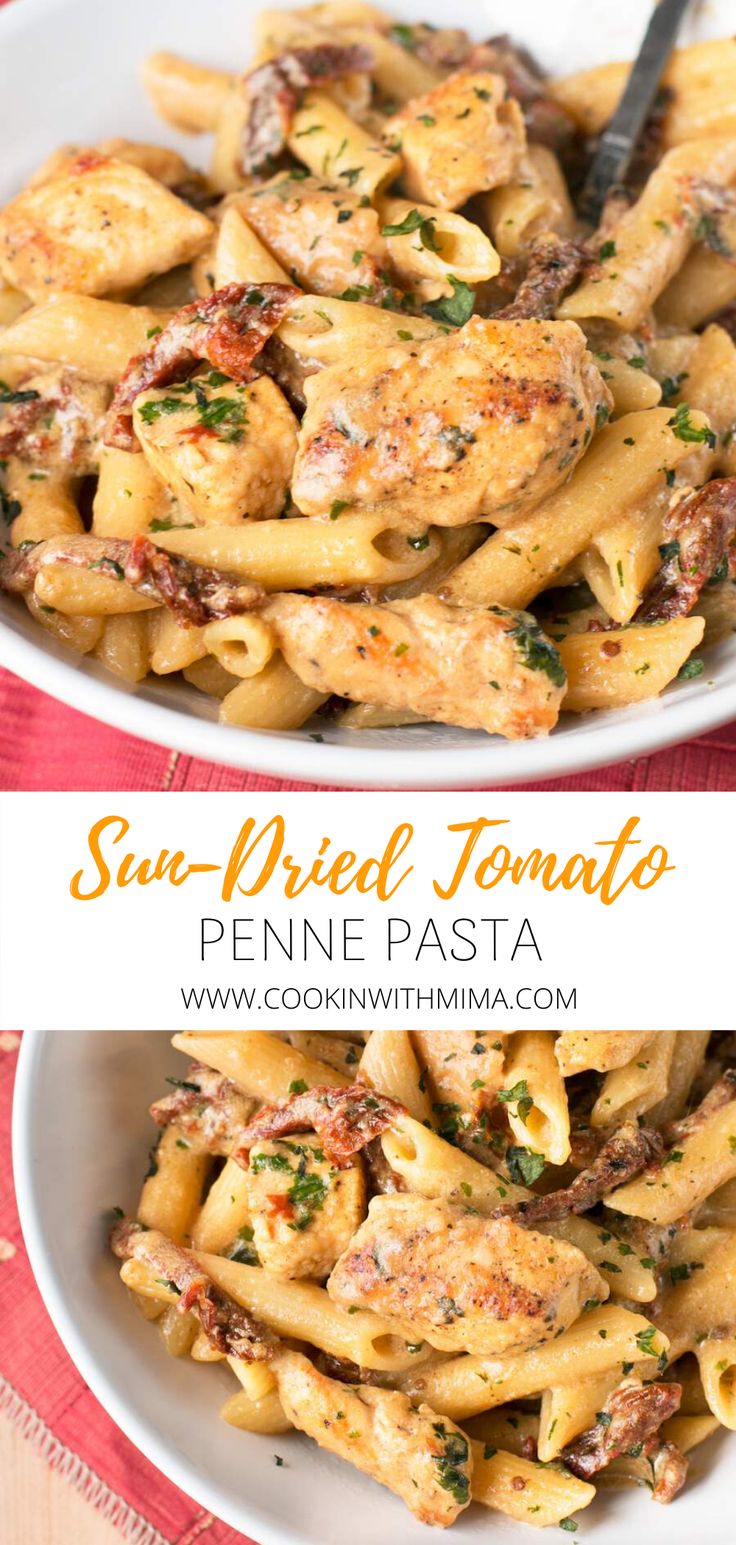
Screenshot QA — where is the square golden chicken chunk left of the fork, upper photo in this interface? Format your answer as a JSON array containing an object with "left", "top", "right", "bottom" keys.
[{"left": 383, "top": 70, "right": 526, "bottom": 209}]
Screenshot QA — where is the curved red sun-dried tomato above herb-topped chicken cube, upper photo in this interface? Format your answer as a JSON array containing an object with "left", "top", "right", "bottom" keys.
[{"left": 105, "top": 284, "right": 298, "bottom": 451}]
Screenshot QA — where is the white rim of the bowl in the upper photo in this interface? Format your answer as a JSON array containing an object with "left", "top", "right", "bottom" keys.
[{"left": 0, "top": 0, "right": 736, "bottom": 789}]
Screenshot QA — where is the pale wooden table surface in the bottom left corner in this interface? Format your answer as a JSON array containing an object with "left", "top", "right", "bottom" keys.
[{"left": 0, "top": 1415, "right": 122, "bottom": 1545}]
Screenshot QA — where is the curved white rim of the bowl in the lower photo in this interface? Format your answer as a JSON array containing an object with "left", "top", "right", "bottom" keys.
[{"left": 11, "top": 1031, "right": 313, "bottom": 1545}]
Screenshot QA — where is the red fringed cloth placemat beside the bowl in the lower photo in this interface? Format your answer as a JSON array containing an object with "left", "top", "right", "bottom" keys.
[{"left": 0, "top": 1032, "right": 255, "bottom": 1545}]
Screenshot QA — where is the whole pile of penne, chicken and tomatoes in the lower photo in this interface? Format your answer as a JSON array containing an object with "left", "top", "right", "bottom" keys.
[{"left": 111, "top": 1031, "right": 736, "bottom": 1528}]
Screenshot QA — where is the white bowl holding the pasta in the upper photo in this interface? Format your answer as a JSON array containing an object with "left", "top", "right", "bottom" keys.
[{"left": 0, "top": 0, "right": 736, "bottom": 788}]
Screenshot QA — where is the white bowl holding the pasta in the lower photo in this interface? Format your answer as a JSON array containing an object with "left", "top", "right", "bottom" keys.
[{"left": 12, "top": 1031, "right": 734, "bottom": 1545}]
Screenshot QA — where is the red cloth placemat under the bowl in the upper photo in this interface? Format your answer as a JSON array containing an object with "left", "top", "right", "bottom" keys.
[{"left": 0, "top": 664, "right": 736, "bottom": 793}]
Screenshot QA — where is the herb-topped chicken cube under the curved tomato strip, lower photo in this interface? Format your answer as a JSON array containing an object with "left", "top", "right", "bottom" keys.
[{"left": 247, "top": 1132, "right": 365, "bottom": 1279}]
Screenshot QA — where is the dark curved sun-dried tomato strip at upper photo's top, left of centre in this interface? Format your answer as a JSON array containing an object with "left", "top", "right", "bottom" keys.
[{"left": 241, "top": 43, "right": 373, "bottom": 175}]
